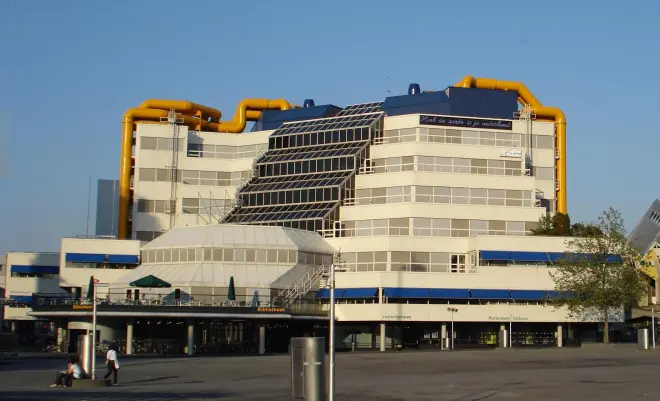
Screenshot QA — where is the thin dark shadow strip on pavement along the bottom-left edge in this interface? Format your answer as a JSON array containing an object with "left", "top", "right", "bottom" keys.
[{"left": 0, "top": 389, "right": 233, "bottom": 401}]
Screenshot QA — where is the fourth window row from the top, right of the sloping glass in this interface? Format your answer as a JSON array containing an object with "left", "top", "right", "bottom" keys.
[{"left": 333, "top": 217, "right": 538, "bottom": 237}]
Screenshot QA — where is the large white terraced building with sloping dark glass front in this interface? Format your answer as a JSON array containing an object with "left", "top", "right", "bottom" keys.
[{"left": 31, "top": 82, "right": 612, "bottom": 349}]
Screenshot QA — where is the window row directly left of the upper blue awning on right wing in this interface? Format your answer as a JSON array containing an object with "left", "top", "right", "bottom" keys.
[{"left": 339, "top": 251, "right": 476, "bottom": 274}]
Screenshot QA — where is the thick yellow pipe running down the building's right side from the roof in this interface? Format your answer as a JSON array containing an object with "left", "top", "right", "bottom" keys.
[{"left": 454, "top": 75, "right": 568, "bottom": 214}]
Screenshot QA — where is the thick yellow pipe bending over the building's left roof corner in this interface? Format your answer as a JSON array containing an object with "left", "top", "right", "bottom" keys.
[{"left": 117, "top": 99, "right": 292, "bottom": 239}]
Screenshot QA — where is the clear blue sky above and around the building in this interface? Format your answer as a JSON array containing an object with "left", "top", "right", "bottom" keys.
[{"left": 0, "top": 0, "right": 660, "bottom": 252}]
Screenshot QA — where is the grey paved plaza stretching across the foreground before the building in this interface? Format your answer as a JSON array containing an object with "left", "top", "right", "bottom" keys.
[{"left": 0, "top": 347, "right": 660, "bottom": 401}]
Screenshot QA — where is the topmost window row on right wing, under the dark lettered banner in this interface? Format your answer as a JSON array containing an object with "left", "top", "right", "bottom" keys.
[{"left": 382, "top": 128, "right": 555, "bottom": 149}]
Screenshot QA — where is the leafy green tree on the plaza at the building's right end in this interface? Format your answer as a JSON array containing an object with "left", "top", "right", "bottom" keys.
[{"left": 551, "top": 208, "right": 647, "bottom": 343}]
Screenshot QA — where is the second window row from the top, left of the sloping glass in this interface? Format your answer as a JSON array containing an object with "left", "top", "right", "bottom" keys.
[{"left": 137, "top": 167, "right": 250, "bottom": 187}]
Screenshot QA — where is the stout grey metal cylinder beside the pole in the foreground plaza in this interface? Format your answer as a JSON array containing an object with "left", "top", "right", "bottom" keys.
[{"left": 290, "top": 337, "right": 327, "bottom": 401}]
